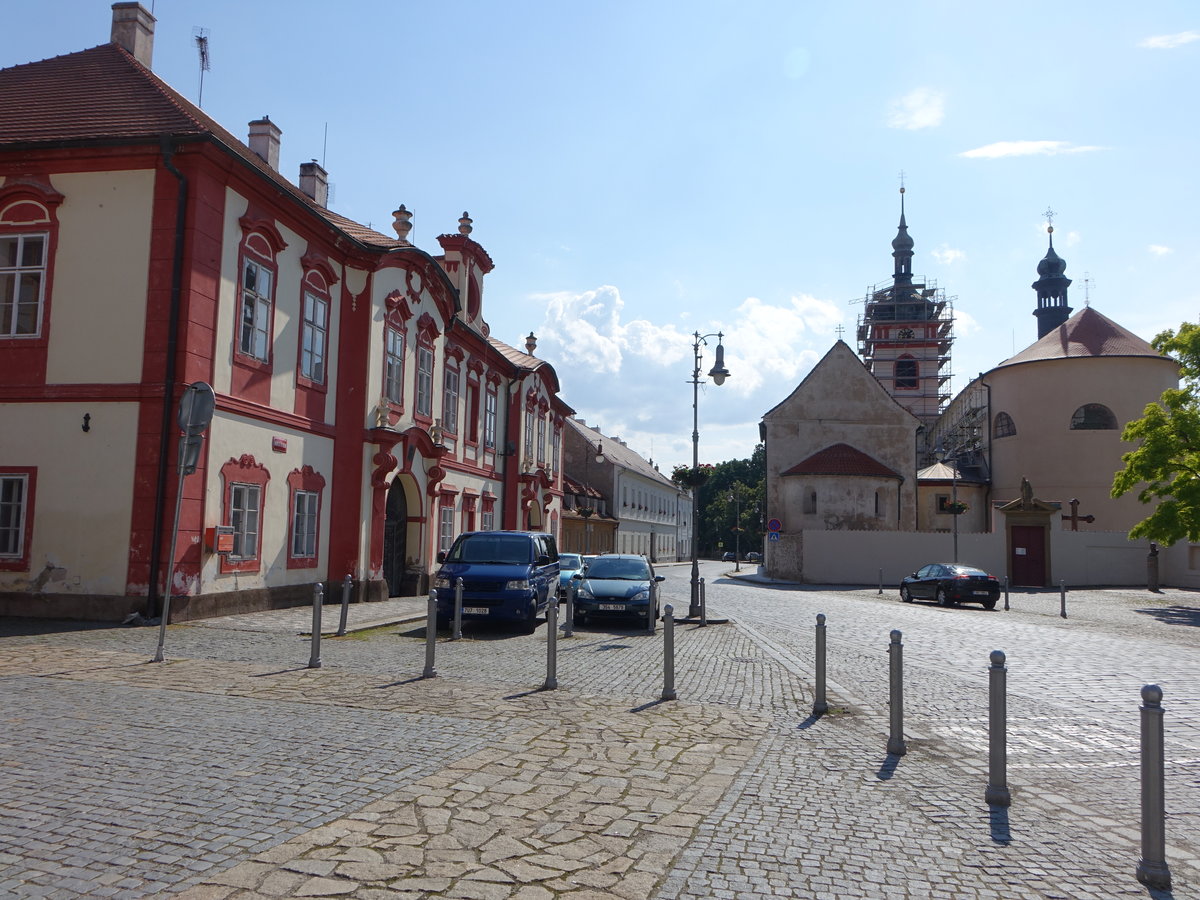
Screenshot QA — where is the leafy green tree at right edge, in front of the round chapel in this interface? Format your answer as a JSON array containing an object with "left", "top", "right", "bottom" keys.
[{"left": 1112, "top": 323, "right": 1200, "bottom": 546}]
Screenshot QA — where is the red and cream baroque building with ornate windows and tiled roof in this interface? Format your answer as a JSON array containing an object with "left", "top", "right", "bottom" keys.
[{"left": 0, "top": 2, "right": 572, "bottom": 619}]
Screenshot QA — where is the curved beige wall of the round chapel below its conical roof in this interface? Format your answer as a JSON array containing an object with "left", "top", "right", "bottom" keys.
[{"left": 988, "top": 358, "right": 1177, "bottom": 532}]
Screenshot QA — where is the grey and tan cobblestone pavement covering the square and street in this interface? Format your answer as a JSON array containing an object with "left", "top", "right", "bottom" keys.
[{"left": 0, "top": 564, "right": 1200, "bottom": 900}]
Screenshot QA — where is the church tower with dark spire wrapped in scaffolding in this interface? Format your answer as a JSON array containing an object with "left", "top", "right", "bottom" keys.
[{"left": 858, "top": 187, "right": 954, "bottom": 425}]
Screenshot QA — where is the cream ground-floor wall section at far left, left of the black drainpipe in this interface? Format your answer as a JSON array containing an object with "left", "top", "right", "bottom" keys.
[{"left": 0, "top": 401, "right": 138, "bottom": 596}]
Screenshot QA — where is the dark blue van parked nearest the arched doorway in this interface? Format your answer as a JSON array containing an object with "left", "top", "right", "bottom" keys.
[{"left": 433, "top": 532, "right": 558, "bottom": 631}]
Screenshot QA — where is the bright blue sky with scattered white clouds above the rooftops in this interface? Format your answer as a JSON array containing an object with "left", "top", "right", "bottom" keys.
[{"left": 0, "top": 0, "right": 1200, "bottom": 472}]
